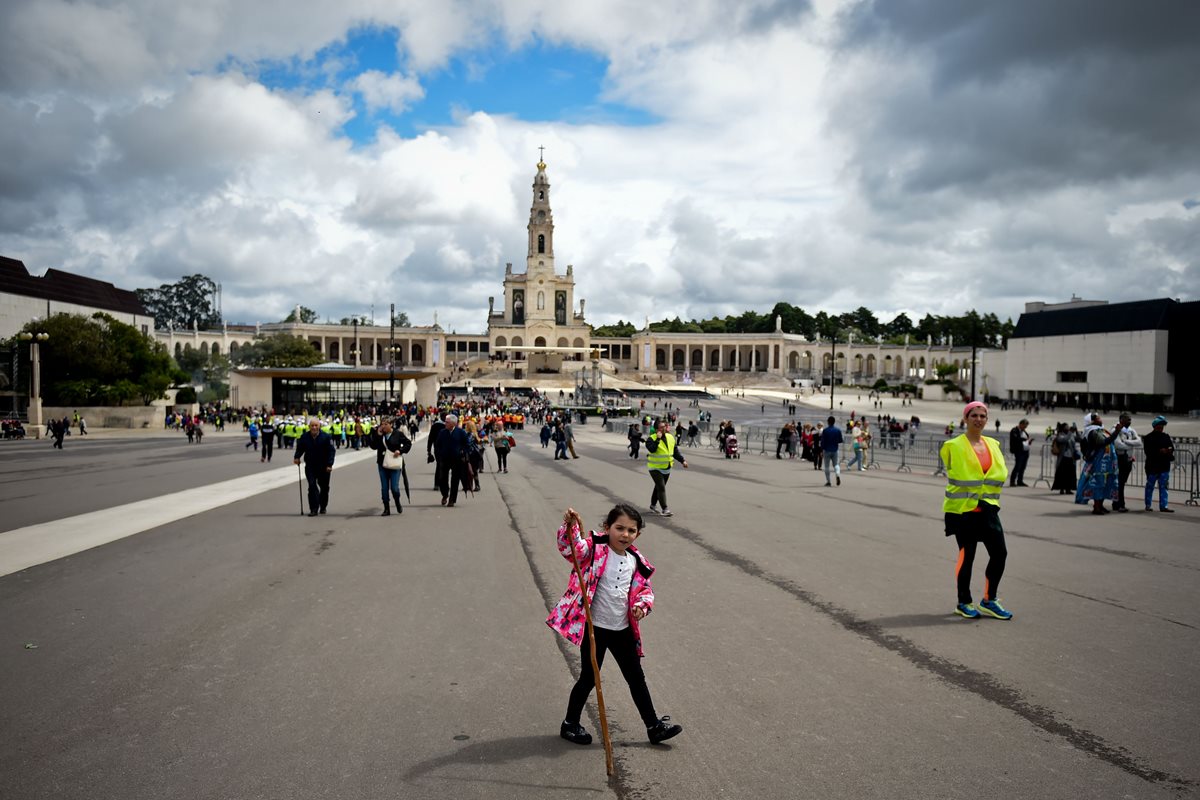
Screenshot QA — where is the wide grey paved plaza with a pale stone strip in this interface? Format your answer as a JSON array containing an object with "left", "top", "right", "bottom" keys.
[{"left": 0, "top": 396, "right": 1200, "bottom": 800}]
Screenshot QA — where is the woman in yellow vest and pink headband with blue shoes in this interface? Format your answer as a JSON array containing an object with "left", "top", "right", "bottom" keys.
[{"left": 941, "top": 402, "right": 1013, "bottom": 619}]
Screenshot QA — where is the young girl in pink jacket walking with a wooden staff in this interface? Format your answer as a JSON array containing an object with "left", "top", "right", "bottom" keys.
[{"left": 546, "top": 504, "right": 683, "bottom": 775}]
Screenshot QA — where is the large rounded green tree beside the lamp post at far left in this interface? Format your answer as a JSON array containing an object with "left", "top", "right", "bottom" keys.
[{"left": 9, "top": 313, "right": 187, "bottom": 405}]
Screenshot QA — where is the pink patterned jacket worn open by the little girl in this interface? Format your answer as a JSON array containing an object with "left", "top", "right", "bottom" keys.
[{"left": 546, "top": 524, "right": 654, "bottom": 656}]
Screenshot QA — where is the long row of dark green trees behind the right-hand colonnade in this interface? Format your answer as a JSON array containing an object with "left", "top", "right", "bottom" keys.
[{"left": 592, "top": 302, "right": 1014, "bottom": 347}]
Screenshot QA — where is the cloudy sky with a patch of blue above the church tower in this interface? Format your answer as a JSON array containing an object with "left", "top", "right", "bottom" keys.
[{"left": 0, "top": 0, "right": 1200, "bottom": 332}]
